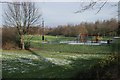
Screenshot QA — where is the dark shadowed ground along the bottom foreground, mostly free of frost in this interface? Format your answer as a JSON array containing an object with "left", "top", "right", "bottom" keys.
[{"left": 3, "top": 51, "right": 117, "bottom": 80}]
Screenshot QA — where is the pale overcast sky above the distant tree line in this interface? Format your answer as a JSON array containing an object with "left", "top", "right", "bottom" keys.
[{"left": 0, "top": 2, "right": 117, "bottom": 27}]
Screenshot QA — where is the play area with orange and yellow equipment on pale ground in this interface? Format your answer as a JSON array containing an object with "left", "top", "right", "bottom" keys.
[{"left": 60, "top": 33, "right": 116, "bottom": 45}]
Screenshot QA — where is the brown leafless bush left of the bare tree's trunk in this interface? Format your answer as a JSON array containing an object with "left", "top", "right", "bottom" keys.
[{"left": 2, "top": 27, "right": 19, "bottom": 49}]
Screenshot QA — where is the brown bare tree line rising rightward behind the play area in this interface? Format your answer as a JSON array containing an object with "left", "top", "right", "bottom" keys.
[{"left": 47, "top": 18, "right": 119, "bottom": 37}]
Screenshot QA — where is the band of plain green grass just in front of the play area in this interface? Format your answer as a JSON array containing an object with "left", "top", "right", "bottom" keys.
[{"left": 31, "top": 43, "right": 113, "bottom": 54}]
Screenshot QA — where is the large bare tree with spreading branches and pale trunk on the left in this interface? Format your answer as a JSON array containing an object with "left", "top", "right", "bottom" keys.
[{"left": 4, "top": 2, "right": 41, "bottom": 49}]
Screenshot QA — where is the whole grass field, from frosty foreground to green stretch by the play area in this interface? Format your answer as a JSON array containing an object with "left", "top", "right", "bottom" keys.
[{"left": 2, "top": 36, "right": 119, "bottom": 78}]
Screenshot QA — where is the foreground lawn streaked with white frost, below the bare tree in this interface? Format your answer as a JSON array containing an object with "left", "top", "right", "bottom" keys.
[{"left": 2, "top": 50, "right": 110, "bottom": 78}]
